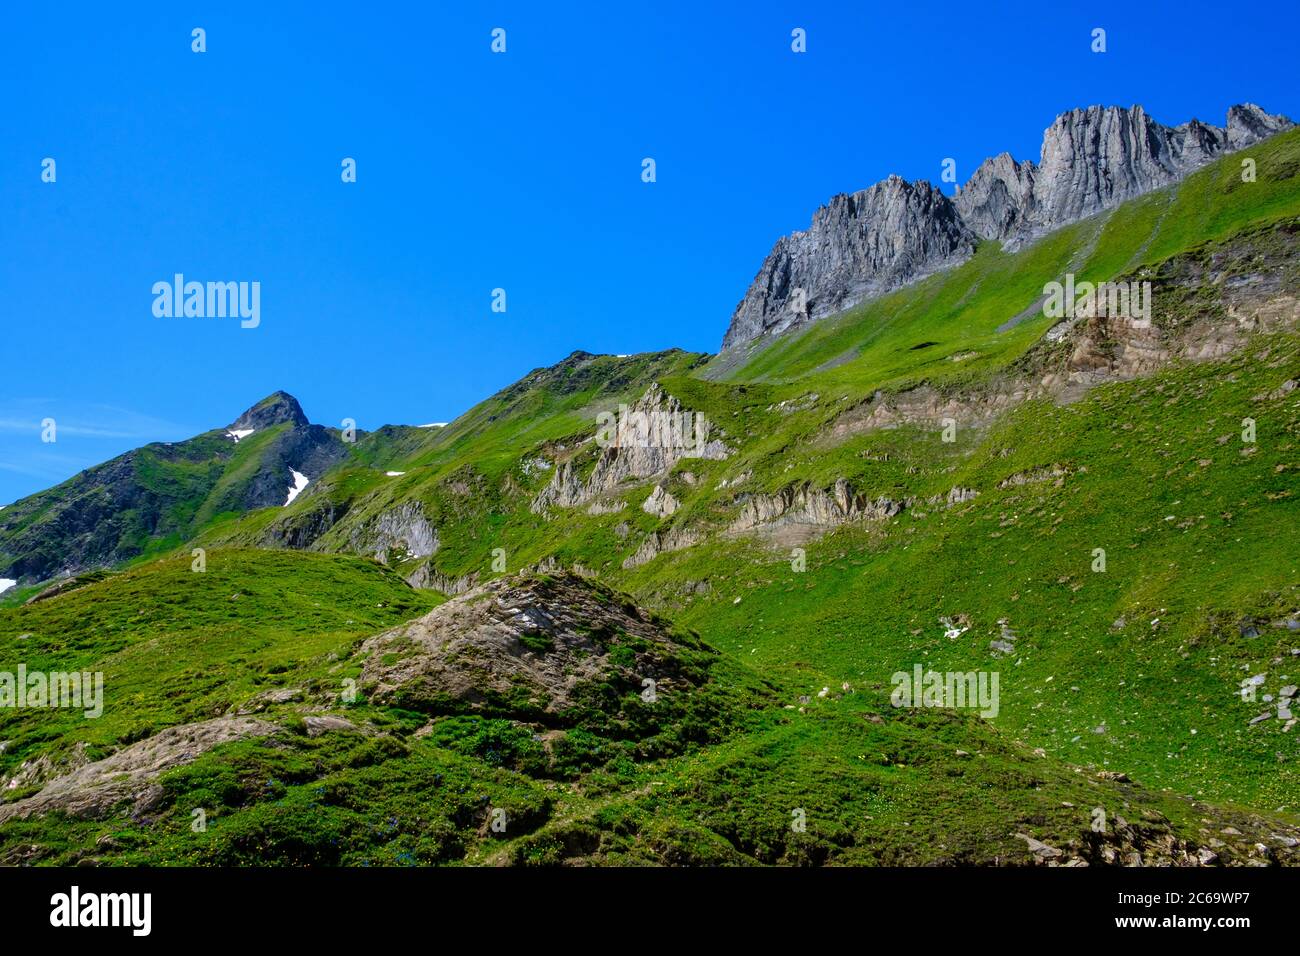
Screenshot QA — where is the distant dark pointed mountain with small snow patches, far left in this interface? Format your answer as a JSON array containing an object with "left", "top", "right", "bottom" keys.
[{"left": 0, "top": 392, "right": 348, "bottom": 585}]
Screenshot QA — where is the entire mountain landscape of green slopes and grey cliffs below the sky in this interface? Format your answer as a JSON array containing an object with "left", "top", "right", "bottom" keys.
[{"left": 0, "top": 113, "right": 1300, "bottom": 868}]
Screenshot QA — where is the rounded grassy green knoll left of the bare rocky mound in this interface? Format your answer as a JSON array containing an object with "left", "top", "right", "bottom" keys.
[{"left": 0, "top": 551, "right": 439, "bottom": 797}]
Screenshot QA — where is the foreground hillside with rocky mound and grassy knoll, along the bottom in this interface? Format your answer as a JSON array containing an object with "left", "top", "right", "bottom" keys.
[{"left": 0, "top": 551, "right": 1300, "bottom": 865}]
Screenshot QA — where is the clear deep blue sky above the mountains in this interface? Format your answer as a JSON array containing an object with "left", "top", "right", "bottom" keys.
[{"left": 0, "top": 0, "right": 1300, "bottom": 503}]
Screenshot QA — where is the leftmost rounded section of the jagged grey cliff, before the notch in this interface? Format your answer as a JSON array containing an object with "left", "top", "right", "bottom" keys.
[{"left": 723, "top": 176, "right": 975, "bottom": 349}]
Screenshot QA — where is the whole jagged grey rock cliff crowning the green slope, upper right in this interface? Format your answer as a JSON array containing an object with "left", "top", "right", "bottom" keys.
[{"left": 723, "top": 103, "right": 1294, "bottom": 350}]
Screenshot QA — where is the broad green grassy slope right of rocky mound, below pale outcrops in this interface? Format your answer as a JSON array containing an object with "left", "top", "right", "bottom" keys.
[{"left": 624, "top": 336, "right": 1300, "bottom": 810}]
